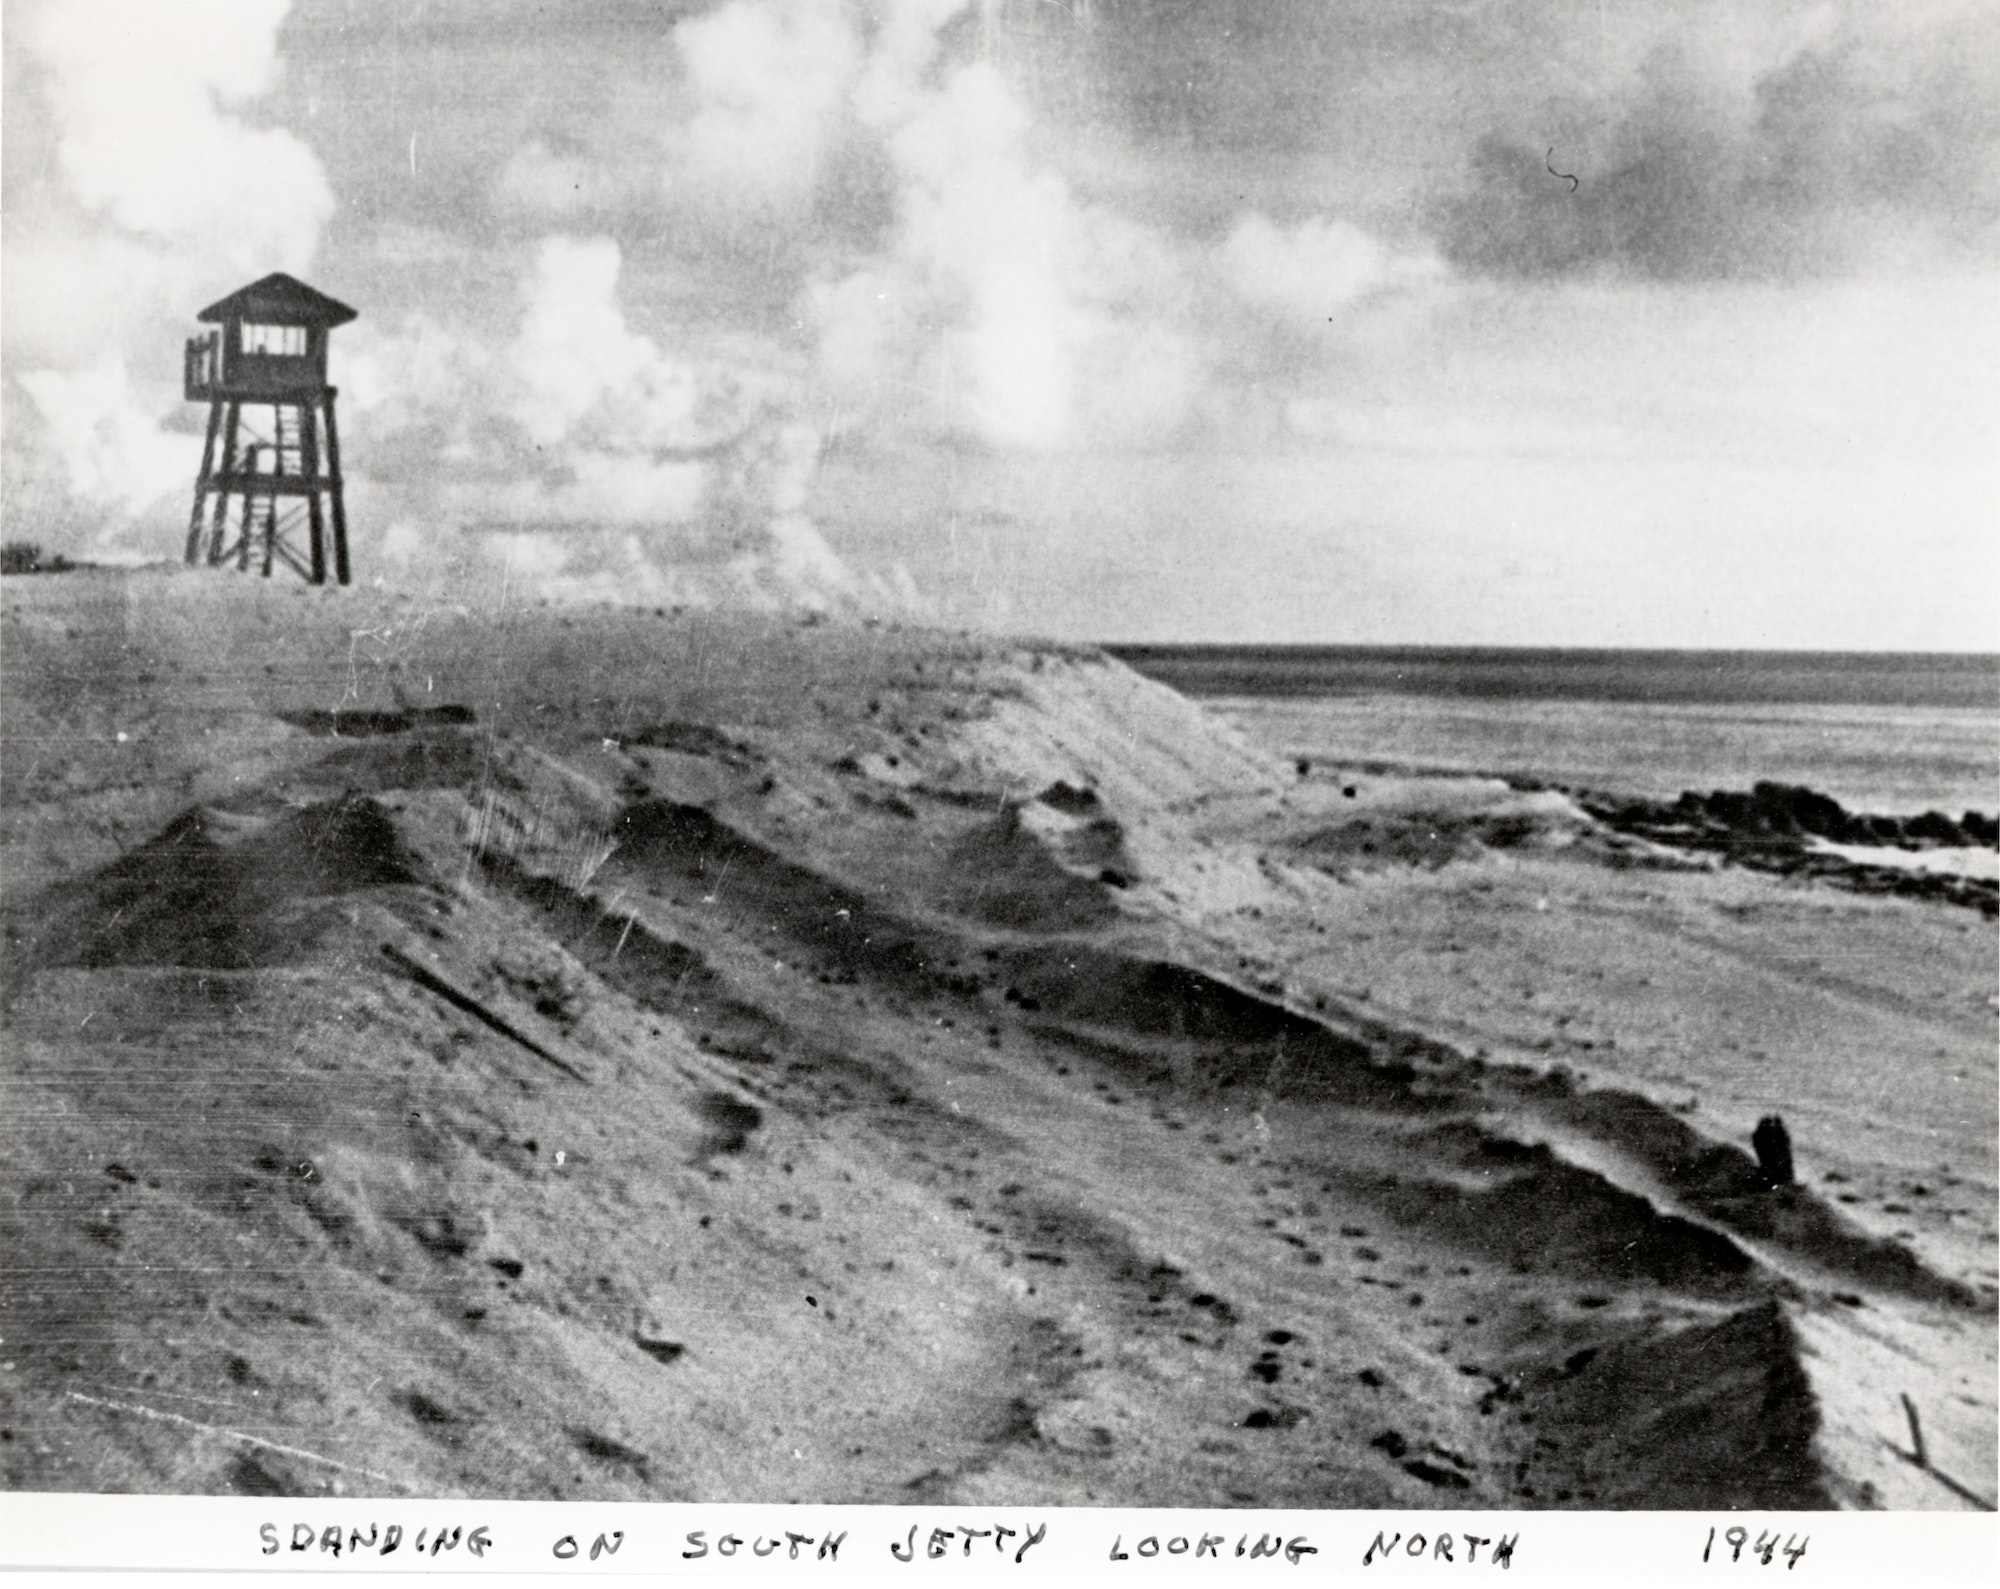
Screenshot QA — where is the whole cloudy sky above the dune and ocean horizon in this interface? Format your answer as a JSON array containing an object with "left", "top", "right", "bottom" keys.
[{"left": 0, "top": 0, "right": 2000, "bottom": 648}]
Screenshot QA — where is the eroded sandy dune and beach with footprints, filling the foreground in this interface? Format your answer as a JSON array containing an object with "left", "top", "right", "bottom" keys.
[{"left": 0, "top": 576, "right": 1994, "bottom": 1507}]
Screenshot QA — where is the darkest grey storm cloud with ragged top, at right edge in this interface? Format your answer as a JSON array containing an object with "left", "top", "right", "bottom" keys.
[{"left": 1434, "top": 28, "right": 2000, "bottom": 280}]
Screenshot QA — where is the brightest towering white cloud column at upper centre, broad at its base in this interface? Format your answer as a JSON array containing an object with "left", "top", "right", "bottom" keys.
[{"left": 772, "top": 10, "right": 1206, "bottom": 450}]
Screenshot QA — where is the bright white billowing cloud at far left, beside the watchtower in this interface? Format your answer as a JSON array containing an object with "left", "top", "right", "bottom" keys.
[{"left": 6, "top": 0, "right": 334, "bottom": 544}]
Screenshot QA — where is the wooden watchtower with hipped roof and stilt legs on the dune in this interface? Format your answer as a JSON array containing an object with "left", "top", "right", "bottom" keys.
[{"left": 186, "top": 272, "right": 356, "bottom": 584}]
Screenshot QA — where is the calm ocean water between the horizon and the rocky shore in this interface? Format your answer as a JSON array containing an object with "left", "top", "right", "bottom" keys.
[{"left": 1112, "top": 646, "right": 2000, "bottom": 817}]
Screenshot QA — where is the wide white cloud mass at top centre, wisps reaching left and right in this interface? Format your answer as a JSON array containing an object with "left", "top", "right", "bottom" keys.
[{"left": 472, "top": 0, "right": 1438, "bottom": 470}]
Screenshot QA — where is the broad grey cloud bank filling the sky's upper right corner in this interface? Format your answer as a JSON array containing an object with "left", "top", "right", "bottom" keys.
[{"left": 1034, "top": 0, "right": 2000, "bottom": 280}]
